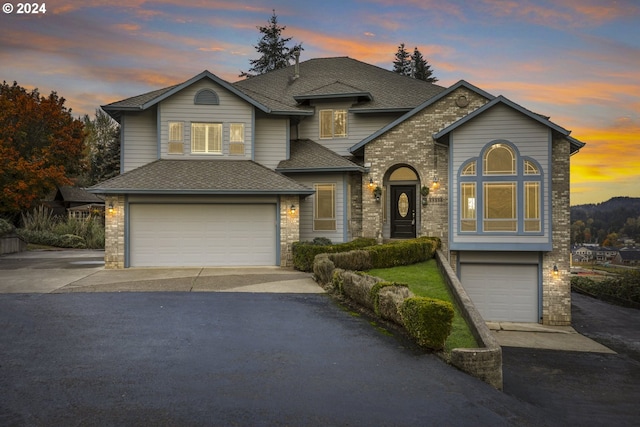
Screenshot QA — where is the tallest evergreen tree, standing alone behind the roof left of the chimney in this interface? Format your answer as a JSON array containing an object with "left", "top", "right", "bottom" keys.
[{"left": 240, "top": 10, "right": 303, "bottom": 77}]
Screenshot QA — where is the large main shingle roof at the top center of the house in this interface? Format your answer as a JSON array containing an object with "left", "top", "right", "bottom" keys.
[{"left": 234, "top": 57, "right": 445, "bottom": 114}]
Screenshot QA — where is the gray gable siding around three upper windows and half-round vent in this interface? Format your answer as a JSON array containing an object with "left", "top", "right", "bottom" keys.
[{"left": 159, "top": 79, "right": 253, "bottom": 159}]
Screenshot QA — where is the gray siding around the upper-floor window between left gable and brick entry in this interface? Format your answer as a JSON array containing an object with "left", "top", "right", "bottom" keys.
[{"left": 291, "top": 101, "right": 398, "bottom": 156}]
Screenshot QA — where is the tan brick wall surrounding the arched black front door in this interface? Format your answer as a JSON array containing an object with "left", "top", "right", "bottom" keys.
[{"left": 361, "top": 87, "right": 488, "bottom": 253}]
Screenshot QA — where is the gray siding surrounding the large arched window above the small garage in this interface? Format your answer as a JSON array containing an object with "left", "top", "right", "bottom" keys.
[{"left": 451, "top": 105, "right": 551, "bottom": 245}]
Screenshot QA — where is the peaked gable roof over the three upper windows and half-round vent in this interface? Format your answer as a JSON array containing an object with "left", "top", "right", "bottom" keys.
[{"left": 102, "top": 70, "right": 270, "bottom": 121}]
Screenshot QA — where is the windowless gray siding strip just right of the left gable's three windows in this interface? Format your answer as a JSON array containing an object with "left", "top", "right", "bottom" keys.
[{"left": 254, "top": 118, "right": 289, "bottom": 169}]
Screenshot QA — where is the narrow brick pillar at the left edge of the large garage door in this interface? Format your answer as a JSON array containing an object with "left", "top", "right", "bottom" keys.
[{"left": 104, "top": 195, "right": 125, "bottom": 269}]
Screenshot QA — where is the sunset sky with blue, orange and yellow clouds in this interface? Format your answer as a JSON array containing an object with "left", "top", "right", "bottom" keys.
[{"left": 0, "top": 0, "right": 640, "bottom": 205}]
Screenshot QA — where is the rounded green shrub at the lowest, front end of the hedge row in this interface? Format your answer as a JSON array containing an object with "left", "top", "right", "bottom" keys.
[{"left": 400, "top": 297, "right": 454, "bottom": 350}]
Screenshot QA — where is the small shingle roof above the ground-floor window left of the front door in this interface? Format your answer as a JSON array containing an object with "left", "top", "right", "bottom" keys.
[{"left": 276, "top": 139, "right": 364, "bottom": 173}]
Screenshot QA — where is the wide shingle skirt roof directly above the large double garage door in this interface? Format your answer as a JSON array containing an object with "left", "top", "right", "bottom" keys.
[{"left": 87, "top": 159, "right": 313, "bottom": 194}]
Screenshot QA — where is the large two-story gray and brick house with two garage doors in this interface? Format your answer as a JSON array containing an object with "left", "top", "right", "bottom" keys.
[{"left": 90, "top": 57, "right": 584, "bottom": 325}]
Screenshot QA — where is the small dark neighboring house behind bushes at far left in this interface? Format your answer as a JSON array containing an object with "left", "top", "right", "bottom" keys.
[{"left": 43, "top": 186, "right": 104, "bottom": 219}]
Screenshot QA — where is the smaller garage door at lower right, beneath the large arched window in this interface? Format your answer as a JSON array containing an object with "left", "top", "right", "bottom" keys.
[{"left": 460, "top": 263, "right": 539, "bottom": 322}]
